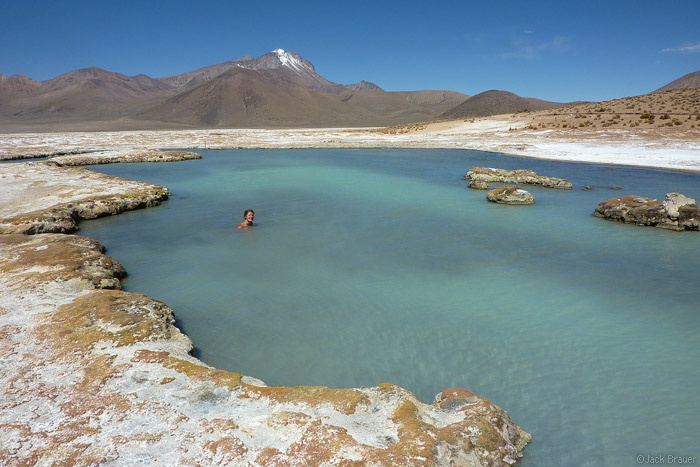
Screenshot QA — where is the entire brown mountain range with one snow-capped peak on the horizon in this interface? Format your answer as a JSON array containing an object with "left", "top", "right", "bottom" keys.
[{"left": 0, "top": 49, "right": 700, "bottom": 132}]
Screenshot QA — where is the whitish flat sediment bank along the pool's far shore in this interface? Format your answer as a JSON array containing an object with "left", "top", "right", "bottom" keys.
[{"left": 0, "top": 116, "right": 700, "bottom": 173}]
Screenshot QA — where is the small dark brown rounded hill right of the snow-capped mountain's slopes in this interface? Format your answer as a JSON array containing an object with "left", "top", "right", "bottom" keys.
[{"left": 441, "top": 90, "right": 566, "bottom": 118}]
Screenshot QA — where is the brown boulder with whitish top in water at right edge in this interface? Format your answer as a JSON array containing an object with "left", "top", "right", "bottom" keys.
[{"left": 593, "top": 193, "right": 700, "bottom": 230}]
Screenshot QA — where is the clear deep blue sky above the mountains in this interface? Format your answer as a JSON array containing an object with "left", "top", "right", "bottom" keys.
[{"left": 0, "top": 0, "right": 700, "bottom": 102}]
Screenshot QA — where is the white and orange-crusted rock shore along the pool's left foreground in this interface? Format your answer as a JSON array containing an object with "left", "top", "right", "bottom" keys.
[{"left": 0, "top": 162, "right": 531, "bottom": 466}]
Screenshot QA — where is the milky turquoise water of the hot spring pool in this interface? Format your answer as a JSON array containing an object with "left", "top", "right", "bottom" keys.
[{"left": 80, "top": 149, "right": 700, "bottom": 467}]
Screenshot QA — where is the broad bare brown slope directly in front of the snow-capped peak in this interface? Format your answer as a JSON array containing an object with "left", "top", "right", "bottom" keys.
[{"left": 137, "top": 68, "right": 463, "bottom": 128}]
